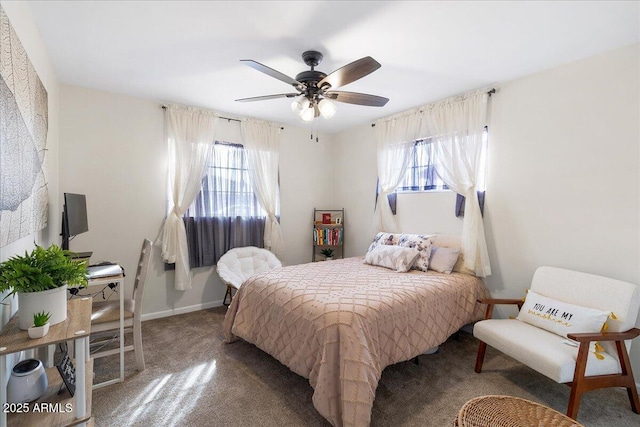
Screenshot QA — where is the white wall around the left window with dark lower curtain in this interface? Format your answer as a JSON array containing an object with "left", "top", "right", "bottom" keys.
[{"left": 60, "top": 85, "right": 333, "bottom": 319}]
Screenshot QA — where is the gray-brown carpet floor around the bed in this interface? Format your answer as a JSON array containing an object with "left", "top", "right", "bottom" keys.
[{"left": 92, "top": 307, "right": 640, "bottom": 427}]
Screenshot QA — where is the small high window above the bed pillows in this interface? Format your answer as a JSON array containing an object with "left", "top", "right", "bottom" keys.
[{"left": 396, "top": 138, "right": 449, "bottom": 192}]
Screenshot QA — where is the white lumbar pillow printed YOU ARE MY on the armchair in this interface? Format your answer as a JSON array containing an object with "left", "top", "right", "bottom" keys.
[{"left": 516, "top": 290, "right": 611, "bottom": 338}]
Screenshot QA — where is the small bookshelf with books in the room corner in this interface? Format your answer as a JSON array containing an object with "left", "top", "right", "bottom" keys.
[{"left": 311, "top": 209, "right": 344, "bottom": 262}]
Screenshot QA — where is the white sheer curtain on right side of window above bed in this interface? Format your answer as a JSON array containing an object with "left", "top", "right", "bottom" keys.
[{"left": 423, "top": 90, "right": 491, "bottom": 277}]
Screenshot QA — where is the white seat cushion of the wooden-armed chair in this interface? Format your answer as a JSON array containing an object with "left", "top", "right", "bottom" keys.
[{"left": 473, "top": 319, "right": 620, "bottom": 383}]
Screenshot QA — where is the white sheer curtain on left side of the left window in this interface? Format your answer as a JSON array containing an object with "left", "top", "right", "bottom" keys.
[{"left": 160, "top": 107, "right": 217, "bottom": 290}]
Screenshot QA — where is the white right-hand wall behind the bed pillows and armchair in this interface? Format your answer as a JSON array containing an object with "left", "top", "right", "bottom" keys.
[{"left": 335, "top": 45, "right": 640, "bottom": 378}]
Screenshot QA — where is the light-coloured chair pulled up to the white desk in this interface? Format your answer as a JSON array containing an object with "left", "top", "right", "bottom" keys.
[{"left": 91, "top": 239, "right": 153, "bottom": 371}]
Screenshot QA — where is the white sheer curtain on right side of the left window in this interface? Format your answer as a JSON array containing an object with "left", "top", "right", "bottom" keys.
[{"left": 240, "top": 119, "right": 284, "bottom": 256}]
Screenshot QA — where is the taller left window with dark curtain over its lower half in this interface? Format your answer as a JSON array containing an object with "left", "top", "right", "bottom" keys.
[{"left": 184, "top": 141, "right": 267, "bottom": 267}]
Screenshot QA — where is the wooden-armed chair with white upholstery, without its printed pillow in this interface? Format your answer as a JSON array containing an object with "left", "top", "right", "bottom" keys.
[{"left": 473, "top": 267, "right": 640, "bottom": 419}]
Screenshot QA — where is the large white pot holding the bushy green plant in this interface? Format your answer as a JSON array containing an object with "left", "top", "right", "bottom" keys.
[{"left": 18, "top": 285, "right": 67, "bottom": 331}]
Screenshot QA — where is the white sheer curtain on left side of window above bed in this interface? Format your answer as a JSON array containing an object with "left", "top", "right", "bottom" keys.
[{"left": 373, "top": 110, "right": 422, "bottom": 232}]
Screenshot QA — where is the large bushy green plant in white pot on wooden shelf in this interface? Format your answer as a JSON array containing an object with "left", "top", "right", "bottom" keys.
[{"left": 0, "top": 245, "right": 87, "bottom": 330}]
